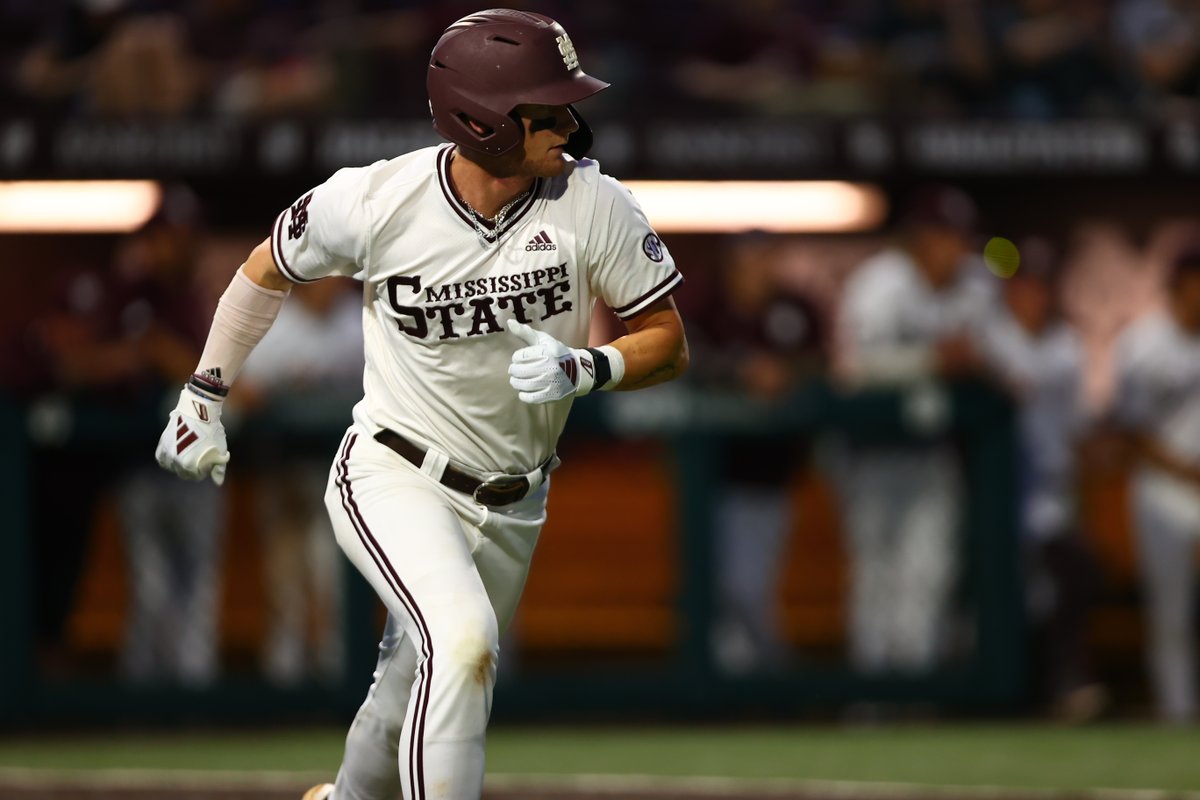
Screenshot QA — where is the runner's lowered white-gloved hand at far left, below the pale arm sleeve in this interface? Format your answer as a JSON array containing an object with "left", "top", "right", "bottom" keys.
[{"left": 155, "top": 386, "right": 229, "bottom": 486}]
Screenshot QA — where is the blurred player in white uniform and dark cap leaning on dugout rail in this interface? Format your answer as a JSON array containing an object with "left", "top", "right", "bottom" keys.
[{"left": 838, "top": 186, "right": 992, "bottom": 673}]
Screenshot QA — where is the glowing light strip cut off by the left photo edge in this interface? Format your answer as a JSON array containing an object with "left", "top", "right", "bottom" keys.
[{"left": 0, "top": 181, "right": 162, "bottom": 234}]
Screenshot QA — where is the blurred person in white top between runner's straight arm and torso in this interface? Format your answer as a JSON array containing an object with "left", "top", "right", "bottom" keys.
[{"left": 235, "top": 279, "right": 362, "bottom": 685}]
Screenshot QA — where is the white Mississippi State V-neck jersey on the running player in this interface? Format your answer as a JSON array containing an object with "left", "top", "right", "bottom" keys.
[{"left": 271, "top": 145, "right": 683, "bottom": 473}]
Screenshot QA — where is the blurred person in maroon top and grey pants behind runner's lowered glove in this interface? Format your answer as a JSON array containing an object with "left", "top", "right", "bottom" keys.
[{"left": 118, "top": 188, "right": 224, "bottom": 686}]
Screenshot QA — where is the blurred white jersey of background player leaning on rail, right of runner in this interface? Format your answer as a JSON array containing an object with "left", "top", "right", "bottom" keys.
[{"left": 838, "top": 248, "right": 995, "bottom": 380}]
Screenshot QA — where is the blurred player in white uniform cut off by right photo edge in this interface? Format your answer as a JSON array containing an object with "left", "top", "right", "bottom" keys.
[{"left": 1115, "top": 248, "right": 1200, "bottom": 722}]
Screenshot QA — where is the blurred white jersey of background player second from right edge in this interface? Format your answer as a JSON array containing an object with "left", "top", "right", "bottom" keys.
[{"left": 984, "top": 311, "right": 1086, "bottom": 537}]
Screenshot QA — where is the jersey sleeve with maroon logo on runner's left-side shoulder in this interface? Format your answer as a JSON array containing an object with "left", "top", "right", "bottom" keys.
[{"left": 271, "top": 168, "right": 371, "bottom": 283}]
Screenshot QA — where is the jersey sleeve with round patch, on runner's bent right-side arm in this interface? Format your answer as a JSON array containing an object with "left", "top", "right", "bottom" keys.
[{"left": 586, "top": 175, "right": 683, "bottom": 320}]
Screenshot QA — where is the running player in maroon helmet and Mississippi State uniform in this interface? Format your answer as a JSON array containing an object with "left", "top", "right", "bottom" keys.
[{"left": 157, "top": 10, "right": 688, "bottom": 800}]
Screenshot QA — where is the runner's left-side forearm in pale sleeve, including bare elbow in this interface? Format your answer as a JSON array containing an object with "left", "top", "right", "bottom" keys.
[{"left": 196, "top": 242, "right": 292, "bottom": 387}]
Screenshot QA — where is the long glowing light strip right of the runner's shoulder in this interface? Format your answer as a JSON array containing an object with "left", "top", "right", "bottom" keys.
[{"left": 623, "top": 181, "right": 888, "bottom": 233}]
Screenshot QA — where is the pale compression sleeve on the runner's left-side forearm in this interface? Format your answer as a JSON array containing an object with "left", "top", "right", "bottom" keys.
[{"left": 196, "top": 267, "right": 288, "bottom": 385}]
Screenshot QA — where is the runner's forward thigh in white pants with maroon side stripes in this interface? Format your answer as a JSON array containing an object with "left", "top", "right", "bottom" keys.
[{"left": 325, "top": 434, "right": 497, "bottom": 644}]
